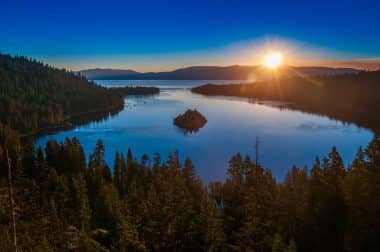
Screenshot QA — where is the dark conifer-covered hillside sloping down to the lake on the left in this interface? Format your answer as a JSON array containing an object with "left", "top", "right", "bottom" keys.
[{"left": 0, "top": 54, "right": 124, "bottom": 133}]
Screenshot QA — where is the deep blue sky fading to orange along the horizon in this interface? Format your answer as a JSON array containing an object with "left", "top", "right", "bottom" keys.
[{"left": 0, "top": 0, "right": 380, "bottom": 71}]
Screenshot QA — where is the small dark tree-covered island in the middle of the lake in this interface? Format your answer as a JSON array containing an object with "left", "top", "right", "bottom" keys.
[{"left": 173, "top": 109, "right": 207, "bottom": 132}]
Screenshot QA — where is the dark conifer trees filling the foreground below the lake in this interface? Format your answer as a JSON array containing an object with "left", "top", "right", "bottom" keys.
[{"left": 0, "top": 134, "right": 380, "bottom": 251}]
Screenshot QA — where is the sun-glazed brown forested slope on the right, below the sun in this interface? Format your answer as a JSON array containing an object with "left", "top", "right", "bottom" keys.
[{"left": 192, "top": 71, "right": 380, "bottom": 133}]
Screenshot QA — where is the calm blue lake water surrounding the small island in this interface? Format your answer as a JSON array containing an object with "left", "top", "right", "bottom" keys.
[{"left": 36, "top": 80, "right": 373, "bottom": 182}]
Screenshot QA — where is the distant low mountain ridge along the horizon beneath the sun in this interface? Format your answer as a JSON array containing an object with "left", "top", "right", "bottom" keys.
[{"left": 79, "top": 65, "right": 360, "bottom": 80}]
